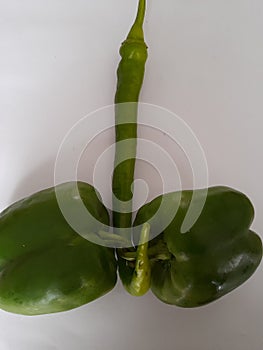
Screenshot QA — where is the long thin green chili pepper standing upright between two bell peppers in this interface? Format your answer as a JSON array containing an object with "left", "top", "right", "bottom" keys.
[{"left": 112, "top": 0, "right": 147, "bottom": 231}]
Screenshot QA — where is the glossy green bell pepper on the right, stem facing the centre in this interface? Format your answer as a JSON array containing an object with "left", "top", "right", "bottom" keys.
[{"left": 135, "top": 187, "right": 262, "bottom": 307}]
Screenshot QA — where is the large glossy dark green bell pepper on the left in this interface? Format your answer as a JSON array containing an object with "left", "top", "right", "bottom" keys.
[{"left": 0, "top": 182, "right": 117, "bottom": 315}]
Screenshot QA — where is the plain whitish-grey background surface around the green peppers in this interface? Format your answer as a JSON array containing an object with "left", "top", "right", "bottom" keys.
[{"left": 0, "top": 0, "right": 263, "bottom": 350}]
